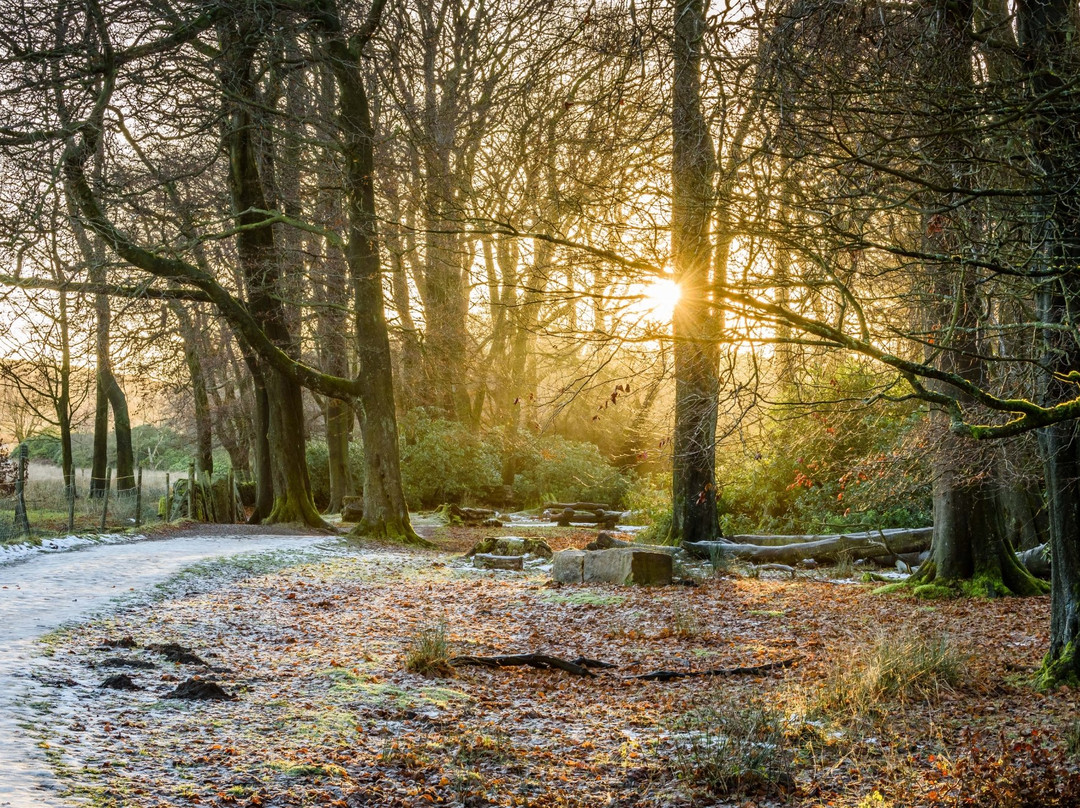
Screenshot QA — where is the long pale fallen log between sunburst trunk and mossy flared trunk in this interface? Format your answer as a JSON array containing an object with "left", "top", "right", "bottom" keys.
[{"left": 683, "top": 527, "right": 933, "bottom": 565}]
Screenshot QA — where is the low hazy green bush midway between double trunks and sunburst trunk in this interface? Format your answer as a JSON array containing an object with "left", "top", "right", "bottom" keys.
[{"left": 514, "top": 435, "right": 633, "bottom": 508}]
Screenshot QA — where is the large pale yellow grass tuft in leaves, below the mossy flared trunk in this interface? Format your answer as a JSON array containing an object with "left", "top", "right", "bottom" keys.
[{"left": 815, "top": 632, "right": 966, "bottom": 716}]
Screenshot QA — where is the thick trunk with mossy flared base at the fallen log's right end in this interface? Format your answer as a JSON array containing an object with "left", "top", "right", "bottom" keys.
[{"left": 910, "top": 0, "right": 1044, "bottom": 597}]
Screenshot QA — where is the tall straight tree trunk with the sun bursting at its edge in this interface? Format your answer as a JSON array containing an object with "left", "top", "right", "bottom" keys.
[{"left": 670, "top": 0, "right": 720, "bottom": 543}]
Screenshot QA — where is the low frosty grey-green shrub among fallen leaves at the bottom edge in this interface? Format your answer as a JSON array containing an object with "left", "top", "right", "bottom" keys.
[{"left": 669, "top": 698, "right": 795, "bottom": 796}]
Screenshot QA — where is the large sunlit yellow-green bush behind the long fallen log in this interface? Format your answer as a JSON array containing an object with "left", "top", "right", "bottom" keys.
[{"left": 717, "top": 362, "right": 930, "bottom": 535}]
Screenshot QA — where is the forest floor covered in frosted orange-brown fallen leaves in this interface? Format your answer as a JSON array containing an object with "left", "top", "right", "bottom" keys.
[{"left": 23, "top": 528, "right": 1080, "bottom": 808}]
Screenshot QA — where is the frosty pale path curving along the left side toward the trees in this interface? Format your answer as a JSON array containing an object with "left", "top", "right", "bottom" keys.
[{"left": 0, "top": 528, "right": 333, "bottom": 808}]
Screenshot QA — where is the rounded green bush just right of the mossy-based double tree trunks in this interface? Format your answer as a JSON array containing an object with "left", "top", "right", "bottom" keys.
[{"left": 401, "top": 408, "right": 502, "bottom": 508}]
